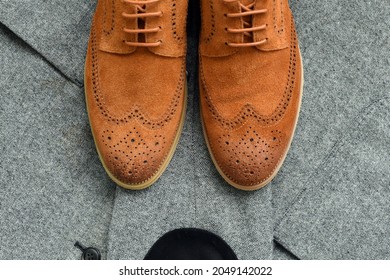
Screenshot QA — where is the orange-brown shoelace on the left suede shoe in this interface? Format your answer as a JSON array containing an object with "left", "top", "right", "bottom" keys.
[{"left": 122, "top": 0, "right": 163, "bottom": 47}]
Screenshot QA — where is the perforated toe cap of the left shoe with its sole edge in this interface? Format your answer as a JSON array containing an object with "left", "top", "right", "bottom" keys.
[{"left": 96, "top": 127, "right": 172, "bottom": 189}]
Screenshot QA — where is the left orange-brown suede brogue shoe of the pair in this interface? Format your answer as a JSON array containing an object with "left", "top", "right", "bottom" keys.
[{"left": 85, "top": 0, "right": 187, "bottom": 190}]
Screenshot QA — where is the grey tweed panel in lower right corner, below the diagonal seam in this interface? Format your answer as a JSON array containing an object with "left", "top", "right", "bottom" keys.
[{"left": 276, "top": 97, "right": 390, "bottom": 259}]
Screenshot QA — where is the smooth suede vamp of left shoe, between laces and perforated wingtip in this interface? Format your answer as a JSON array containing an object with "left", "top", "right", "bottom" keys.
[{"left": 98, "top": 48, "right": 183, "bottom": 120}]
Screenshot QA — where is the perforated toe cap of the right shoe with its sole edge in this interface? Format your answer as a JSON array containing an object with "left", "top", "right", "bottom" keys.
[{"left": 211, "top": 125, "right": 288, "bottom": 190}]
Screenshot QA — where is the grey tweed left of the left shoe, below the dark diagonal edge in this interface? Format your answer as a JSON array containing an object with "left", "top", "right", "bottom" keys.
[{"left": 0, "top": 26, "right": 115, "bottom": 259}]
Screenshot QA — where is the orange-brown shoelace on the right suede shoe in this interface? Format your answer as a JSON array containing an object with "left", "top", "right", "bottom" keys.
[{"left": 223, "top": 0, "right": 268, "bottom": 47}]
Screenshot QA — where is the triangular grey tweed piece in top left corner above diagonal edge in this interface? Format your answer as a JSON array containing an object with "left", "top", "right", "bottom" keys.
[{"left": 0, "top": 0, "right": 95, "bottom": 86}]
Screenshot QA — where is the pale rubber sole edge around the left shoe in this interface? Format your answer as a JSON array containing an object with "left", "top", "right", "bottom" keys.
[{"left": 84, "top": 77, "right": 187, "bottom": 190}]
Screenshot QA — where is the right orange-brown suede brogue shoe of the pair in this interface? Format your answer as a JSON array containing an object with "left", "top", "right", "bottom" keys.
[{"left": 199, "top": 0, "right": 303, "bottom": 190}]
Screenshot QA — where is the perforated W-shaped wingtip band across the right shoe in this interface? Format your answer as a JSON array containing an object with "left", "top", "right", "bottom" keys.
[{"left": 200, "top": 18, "right": 297, "bottom": 129}]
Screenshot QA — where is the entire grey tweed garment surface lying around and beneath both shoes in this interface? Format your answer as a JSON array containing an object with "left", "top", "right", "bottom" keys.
[{"left": 0, "top": 0, "right": 390, "bottom": 259}]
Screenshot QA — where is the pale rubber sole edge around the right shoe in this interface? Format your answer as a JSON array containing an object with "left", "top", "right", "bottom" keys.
[{"left": 200, "top": 48, "right": 304, "bottom": 191}]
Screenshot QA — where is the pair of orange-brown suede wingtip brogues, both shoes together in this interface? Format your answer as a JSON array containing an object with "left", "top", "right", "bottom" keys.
[{"left": 85, "top": 0, "right": 303, "bottom": 190}]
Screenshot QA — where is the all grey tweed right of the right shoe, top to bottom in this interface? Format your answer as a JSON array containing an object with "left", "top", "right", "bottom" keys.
[{"left": 272, "top": 1, "right": 390, "bottom": 259}]
